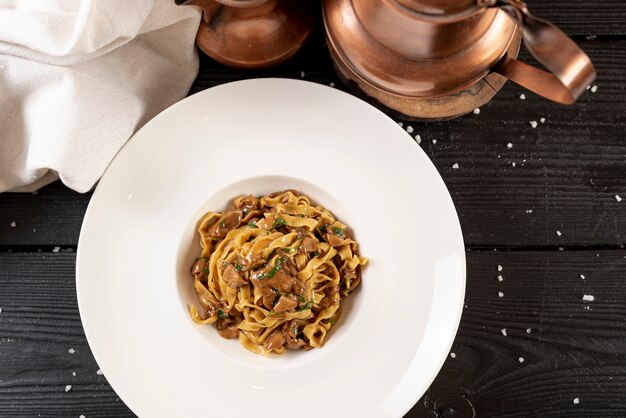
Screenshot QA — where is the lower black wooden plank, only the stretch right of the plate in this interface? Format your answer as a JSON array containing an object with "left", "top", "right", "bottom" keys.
[{"left": 408, "top": 250, "right": 626, "bottom": 417}]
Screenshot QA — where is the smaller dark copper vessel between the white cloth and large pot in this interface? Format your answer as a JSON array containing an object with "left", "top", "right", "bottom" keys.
[{"left": 183, "top": 0, "right": 315, "bottom": 68}]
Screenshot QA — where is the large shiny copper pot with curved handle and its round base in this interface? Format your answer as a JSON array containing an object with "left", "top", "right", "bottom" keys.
[{"left": 323, "top": 0, "right": 595, "bottom": 120}]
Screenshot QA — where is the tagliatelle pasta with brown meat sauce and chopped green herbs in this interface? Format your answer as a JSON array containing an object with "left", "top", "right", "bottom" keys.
[{"left": 189, "top": 190, "right": 367, "bottom": 355}]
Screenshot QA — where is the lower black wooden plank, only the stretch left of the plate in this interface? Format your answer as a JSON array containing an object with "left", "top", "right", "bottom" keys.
[{"left": 0, "top": 253, "right": 133, "bottom": 417}]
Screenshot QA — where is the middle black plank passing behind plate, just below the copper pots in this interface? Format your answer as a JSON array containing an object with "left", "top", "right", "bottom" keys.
[{"left": 0, "top": 39, "right": 626, "bottom": 251}]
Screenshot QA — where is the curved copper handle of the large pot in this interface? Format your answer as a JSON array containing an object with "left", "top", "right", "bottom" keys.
[{"left": 488, "top": 0, "right": 596, "bottom": 104}]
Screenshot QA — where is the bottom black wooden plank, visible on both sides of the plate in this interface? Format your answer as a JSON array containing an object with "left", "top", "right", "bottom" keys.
[{"left": 0, "top": 250, "right": 626, "bottom": 417}]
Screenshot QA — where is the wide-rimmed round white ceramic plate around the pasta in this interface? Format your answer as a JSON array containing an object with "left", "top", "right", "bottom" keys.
[{"left": 76, "top": 79, "right": 465, "bottom": 418}]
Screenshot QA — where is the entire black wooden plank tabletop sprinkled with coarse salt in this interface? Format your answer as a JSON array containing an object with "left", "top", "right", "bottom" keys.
[{"left": 0, "top": 0, "right": 626, "bottom": 418}]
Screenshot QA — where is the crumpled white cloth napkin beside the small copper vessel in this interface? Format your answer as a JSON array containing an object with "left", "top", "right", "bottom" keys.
[{"left": 0, "top": 0, "right": 201, "bottom": 192}]
